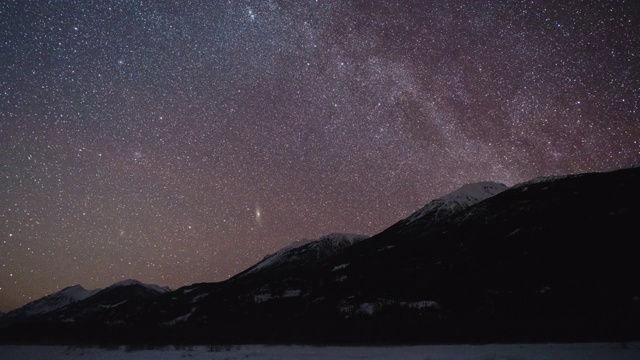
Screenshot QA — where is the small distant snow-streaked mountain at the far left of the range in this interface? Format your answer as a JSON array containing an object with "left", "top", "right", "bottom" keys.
[{"left": 5, "top": 285, "right": 100, "bottom": 320}]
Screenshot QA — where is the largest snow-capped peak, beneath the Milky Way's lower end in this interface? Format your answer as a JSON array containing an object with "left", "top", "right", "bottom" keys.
[{"left": 405, "top": 181, "right": 508, "bottom": 224}]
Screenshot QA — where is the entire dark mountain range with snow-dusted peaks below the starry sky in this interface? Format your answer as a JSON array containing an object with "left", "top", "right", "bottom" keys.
[{"left": 0, "top": 167, "right": 640, "bottom": 343}]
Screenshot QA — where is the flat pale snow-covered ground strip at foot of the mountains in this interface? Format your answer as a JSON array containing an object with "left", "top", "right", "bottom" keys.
[{"left": 0, "top": 343, "right": 640, "bottom": 360}]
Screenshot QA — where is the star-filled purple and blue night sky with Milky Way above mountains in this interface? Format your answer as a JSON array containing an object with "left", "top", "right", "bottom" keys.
[{"left": 0, "top": 0, "right": 640, "bottom": 311}]
